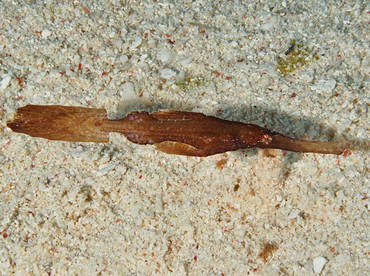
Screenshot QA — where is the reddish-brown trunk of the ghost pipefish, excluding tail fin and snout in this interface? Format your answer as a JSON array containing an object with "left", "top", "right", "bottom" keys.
[{"left": 103, "top": 110, "right": 272, "bottom": 156}]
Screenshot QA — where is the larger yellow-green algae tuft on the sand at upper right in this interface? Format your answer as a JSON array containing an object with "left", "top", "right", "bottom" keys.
[{"left": 276, "top": 39, "right": 318, "bottom": 77}]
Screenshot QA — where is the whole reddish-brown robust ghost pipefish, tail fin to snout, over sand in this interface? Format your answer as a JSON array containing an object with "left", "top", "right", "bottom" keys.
[{"left": 7, "top": 105, "right": 348, "bottom": 156}]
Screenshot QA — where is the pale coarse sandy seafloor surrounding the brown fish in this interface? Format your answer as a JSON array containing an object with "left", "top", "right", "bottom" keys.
[{"left": 0, "top": 0, "right": 370, "bottom": 275}]
